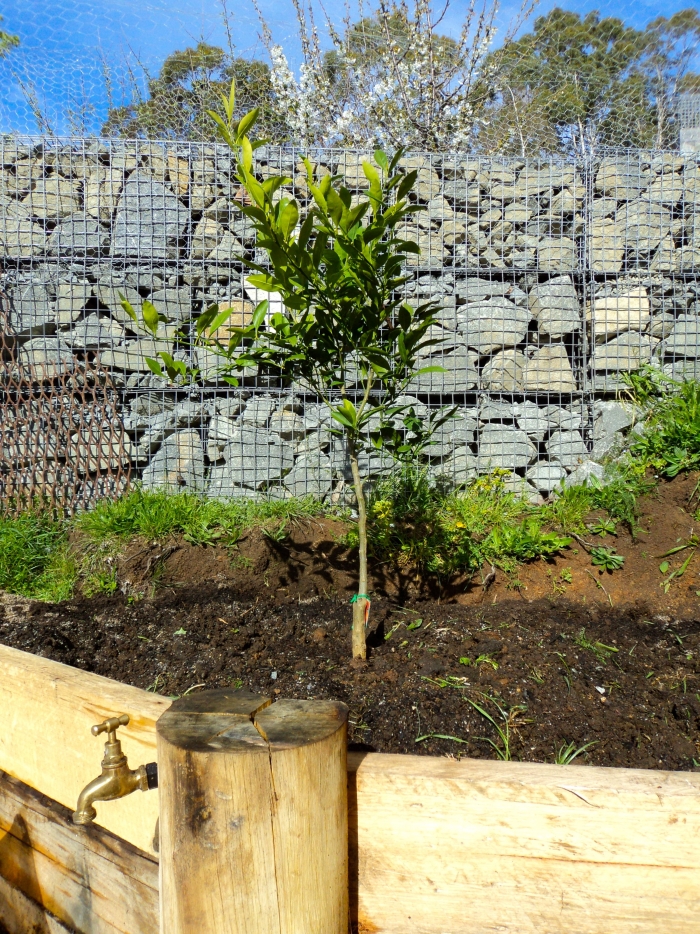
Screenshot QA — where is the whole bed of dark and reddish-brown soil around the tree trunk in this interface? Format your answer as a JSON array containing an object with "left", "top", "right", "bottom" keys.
[{"left": 0, "top": 475, "right": 700, "bottom": 769}]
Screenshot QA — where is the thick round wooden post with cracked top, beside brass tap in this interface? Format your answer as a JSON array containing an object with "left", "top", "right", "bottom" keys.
[{"left": 157, "top": 689, "right": 348, "bottom": 934}]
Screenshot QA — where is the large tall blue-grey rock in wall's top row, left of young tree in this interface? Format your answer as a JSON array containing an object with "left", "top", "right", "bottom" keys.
[{"left": 112, "top": 171, "right": 188, "bottom": 259}]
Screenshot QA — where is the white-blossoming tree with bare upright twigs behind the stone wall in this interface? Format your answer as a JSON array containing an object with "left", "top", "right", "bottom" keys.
[{"left": 262, "top": 0, "right": 530, "bottom": 152}]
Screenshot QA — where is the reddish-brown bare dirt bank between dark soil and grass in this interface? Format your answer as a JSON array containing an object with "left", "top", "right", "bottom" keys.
[{"left": 118, "top": 474, "right": 700, "bottom": 615}]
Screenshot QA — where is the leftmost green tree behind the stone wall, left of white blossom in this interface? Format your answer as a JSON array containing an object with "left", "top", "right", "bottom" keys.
[{"left": 102, "top": 42, "right": 288, "bottom": 142}]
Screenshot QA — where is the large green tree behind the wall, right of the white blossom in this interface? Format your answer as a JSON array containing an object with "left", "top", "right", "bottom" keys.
[{"left": 480, "top": 9, "right": 700, "bottom": 155}]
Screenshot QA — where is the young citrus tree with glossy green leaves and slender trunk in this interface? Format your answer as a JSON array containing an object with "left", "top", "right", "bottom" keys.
[{"left": 129, "top": 85, "right": 444, "bottom": 658}]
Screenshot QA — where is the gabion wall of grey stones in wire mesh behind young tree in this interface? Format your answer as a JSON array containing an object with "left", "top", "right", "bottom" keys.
[{"left": 0, "top": 139, "right": 700, "bottom": 509}]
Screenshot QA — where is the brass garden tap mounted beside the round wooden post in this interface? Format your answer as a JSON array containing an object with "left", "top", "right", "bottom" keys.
[{"left": 73, "top": 713, "right": 158, "bottom": 824}]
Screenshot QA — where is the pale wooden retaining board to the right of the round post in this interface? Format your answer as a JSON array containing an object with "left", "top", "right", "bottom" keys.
[{"left": 349, "top": 755, "right": 700, "bottom": 934}]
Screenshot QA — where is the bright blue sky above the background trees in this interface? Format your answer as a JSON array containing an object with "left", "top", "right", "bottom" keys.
[{"left": 0, "top": 0, "right": 692, "bottom": 133}]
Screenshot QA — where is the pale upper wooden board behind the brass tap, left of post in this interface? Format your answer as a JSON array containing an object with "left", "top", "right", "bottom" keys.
[{"left": 0, "top": 646, "right": 170, "bottom": 854}]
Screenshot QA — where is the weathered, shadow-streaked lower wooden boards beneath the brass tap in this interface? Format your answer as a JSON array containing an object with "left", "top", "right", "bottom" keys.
[{"left": 0, "top": 773, "right": 158, "bottom": 934}]
